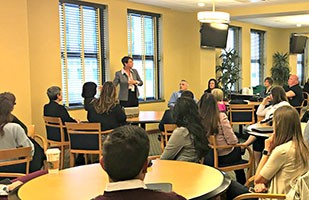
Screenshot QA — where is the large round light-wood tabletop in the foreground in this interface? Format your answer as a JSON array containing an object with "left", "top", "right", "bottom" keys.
[{"left": 18, "top": 160, "right": 230, "bottom": 200}]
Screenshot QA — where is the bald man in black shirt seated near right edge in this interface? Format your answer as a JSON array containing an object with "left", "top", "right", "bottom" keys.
[{"left": 286, "top": 74, "right": 304, "bottom": 106}]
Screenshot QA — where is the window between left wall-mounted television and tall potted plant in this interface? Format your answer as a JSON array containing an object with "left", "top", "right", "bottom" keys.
[{"left": 225, "top": 26, "right": 241, "bottom": 91}]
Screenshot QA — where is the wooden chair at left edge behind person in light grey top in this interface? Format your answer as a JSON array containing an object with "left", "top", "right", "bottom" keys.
[{"left": 0, "top": 147, "right": 32, "bottom": 177}]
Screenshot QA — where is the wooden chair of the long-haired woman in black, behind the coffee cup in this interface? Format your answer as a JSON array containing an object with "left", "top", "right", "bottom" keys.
[{"left": 65, "top": 122, "right": 112, "bottom": 167}]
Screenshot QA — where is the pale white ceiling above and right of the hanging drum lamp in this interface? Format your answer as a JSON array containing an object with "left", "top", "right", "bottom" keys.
[{"left": 129, "top": 0, "right": 309, "bottom": 28}]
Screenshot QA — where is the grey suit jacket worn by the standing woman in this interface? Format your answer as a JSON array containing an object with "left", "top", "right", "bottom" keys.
[{"left": 113, "top": 69, "right": 143, "bottom": 101}]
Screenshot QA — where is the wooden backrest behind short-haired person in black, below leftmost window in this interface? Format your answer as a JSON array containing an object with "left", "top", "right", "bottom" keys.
[{"left": 43, "top": 116, "right": 68, "bottom": 142}]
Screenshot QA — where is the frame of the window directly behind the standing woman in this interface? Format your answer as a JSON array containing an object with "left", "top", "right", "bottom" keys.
[{"left": 127, "top": 9, "right": 163, "bottom": 103}]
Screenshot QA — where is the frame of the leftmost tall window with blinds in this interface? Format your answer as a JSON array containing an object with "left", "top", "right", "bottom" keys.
[{"left": 58, "top": 0, "right": 107, "bottom": 109}]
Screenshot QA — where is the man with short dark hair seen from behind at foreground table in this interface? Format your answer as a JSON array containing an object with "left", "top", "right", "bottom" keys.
[{"left": 95, "top": 125, "right": 185, "bottom": 200}]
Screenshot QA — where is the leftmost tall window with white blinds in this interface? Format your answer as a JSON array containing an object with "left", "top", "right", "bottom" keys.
[{"left": 59, "top": 0, "right": 106, "bottom": 106}]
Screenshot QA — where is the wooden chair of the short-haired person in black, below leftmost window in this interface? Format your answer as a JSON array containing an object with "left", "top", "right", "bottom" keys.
[{"left": 43, "top": 116, "right": 70, "bottom": 169}]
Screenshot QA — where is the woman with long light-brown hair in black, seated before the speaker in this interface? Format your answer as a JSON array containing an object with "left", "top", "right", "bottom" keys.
[{"left": 88, "top": 81, "right": 127, "bottom": 130}]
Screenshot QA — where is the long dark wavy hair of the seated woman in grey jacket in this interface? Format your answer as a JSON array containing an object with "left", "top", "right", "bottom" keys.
[{"left": 173, "top": 97, "right": 209, "bottom": 157}]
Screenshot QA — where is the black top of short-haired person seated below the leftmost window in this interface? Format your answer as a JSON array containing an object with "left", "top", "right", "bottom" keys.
[{"left": 44, "top": 101, "right": 76, "bottom": 123}]
